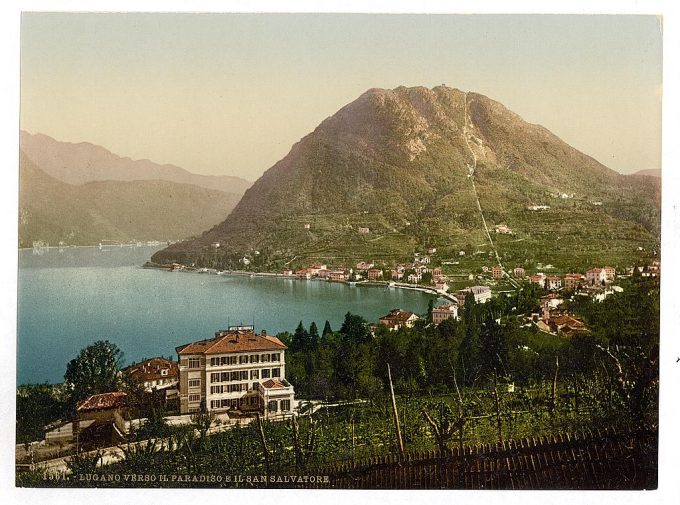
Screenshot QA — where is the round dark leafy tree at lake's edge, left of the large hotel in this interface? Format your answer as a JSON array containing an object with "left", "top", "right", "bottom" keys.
[{"left": 64, "top": 340, "right": 123, "bottom": 408}]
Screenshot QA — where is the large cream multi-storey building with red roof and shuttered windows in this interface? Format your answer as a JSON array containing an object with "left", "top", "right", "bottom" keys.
[{"left": 176, "top": 326, "right": 295, "bottom": 416}]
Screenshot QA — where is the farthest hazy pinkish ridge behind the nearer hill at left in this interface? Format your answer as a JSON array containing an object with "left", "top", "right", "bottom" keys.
[{"left": 19, "top": 131, "right": 251, "bottom": 194}]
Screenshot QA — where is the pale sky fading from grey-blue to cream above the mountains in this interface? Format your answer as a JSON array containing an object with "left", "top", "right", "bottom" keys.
[{"left": 21, "top": 13, "right": 662, "bottom": 180}]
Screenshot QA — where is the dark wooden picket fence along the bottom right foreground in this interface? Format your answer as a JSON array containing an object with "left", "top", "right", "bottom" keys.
[{"left": 306, "top": 430, "right": 658, "bottom": 489}]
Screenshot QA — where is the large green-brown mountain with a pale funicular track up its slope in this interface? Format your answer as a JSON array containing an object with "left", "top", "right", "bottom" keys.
[{"left": 153, "top": 86, "right": 660, "bottom": 268}]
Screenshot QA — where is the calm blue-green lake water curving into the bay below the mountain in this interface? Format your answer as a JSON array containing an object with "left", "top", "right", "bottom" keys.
[{"left": 17, "top": 247, "right": 432, "bottom": 384}]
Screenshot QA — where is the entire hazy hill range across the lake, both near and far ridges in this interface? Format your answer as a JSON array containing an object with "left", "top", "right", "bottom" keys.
[{"left": 19, "top": 132, "right": 249, "bottom": 247}]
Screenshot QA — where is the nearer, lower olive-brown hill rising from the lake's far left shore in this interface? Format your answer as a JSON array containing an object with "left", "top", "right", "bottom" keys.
[{"left": 19, "top": 151, "right": 240, "bottom": 247}]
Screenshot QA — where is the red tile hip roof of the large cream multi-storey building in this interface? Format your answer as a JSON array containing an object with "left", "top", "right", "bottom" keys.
[{"left": 176, "top": 330, "right": 287, "bottom": 356}]
